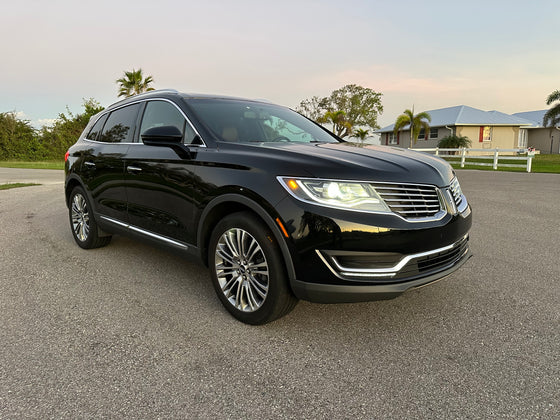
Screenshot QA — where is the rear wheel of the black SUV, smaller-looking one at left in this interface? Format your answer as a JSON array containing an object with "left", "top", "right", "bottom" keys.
[{"left": 68, "top": 187, "right": 111, "bottom": 249}]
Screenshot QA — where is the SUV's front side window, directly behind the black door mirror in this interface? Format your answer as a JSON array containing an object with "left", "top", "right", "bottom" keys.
[{"left": 140, "top": 101, "right": 195, "bottom": 144}]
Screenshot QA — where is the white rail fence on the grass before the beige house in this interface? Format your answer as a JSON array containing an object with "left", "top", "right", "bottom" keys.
[{"left": 410, "top": 147, "right": 535, "bottom": 172}]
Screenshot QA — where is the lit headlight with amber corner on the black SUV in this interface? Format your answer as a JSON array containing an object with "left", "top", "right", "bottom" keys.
[{"left": 278, "top": 177, "right": 390, "bottom": 213}]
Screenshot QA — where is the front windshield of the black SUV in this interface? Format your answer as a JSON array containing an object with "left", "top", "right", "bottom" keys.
[{"left": 187, "top": 99, "right": 338, "bottom": 143}]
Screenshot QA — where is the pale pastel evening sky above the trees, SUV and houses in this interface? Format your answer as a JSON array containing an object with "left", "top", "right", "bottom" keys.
[{"left": 0, "top": 0, "right": 560, "bottom": 127}]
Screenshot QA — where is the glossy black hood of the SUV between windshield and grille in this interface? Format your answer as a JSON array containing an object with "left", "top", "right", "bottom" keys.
[{"left": 249, "top": 142, "right": 454, "bottom": 187}]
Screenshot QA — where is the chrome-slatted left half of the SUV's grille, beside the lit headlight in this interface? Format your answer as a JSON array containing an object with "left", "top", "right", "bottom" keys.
[{"left": 373, "top": 183, "right": 442, "bottom": 219}]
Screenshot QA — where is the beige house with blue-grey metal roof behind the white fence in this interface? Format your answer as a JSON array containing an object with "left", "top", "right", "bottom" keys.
[{"left": 376, "top": 105, "right": 560, "bottom": 153}]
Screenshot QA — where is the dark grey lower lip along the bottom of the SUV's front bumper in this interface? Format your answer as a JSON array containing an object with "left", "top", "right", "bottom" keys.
[{"left": 292, "top": 244, "right": 472, "bottom": 303}]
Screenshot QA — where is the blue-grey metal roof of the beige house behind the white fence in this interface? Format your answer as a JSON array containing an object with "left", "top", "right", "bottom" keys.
[{"left": 376, "top": 105, "right": 532, "bottom": 133}]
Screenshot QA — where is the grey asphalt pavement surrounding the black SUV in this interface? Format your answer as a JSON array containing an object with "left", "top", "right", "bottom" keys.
[{"left": 0, "top": 171, "right": 560, "bottom": 419}]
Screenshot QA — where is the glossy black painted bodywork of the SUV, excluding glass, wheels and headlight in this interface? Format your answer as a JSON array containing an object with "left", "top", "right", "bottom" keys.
[{"left": 66, "top": 92, "right": 471, "bottom": 302}]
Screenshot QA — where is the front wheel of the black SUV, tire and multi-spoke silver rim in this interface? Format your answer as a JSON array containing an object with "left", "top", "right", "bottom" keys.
[{"left": 208, "top": 212, "right": 297, "bottom": 325}]
